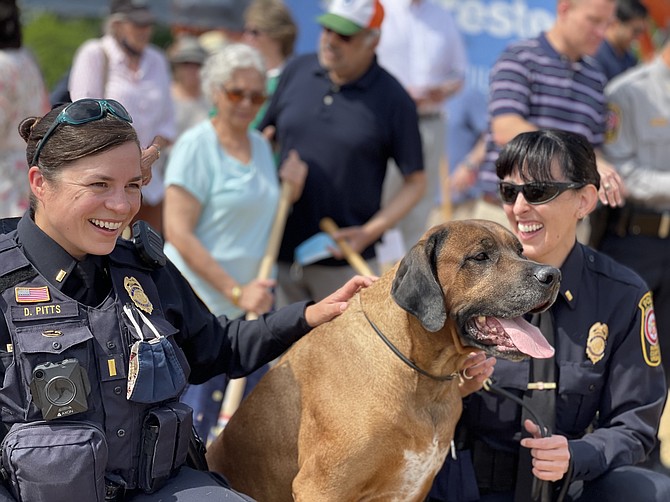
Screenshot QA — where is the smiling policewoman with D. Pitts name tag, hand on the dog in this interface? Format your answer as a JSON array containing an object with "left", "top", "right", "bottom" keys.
[{"left": 0, "top": 99, "right": 370, "bottom": 502}]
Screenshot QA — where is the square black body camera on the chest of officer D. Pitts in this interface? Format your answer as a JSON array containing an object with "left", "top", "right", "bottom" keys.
[{"left": 30, "top": 359, "right": 91, "bottom": 420}]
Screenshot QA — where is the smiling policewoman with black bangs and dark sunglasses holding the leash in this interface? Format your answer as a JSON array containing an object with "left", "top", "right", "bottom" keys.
[{"left": 432, "top": 130, "right": 670, "bottom": 502}]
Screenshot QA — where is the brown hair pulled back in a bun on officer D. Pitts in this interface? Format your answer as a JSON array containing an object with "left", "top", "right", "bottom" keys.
[{"left": 19, "top": 104, "right": 140, "bottom": 210}]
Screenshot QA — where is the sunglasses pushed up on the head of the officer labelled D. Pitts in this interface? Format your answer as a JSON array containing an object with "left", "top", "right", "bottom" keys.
[{"left": 32, "top": 98, "right": 133, "bottom": 166}]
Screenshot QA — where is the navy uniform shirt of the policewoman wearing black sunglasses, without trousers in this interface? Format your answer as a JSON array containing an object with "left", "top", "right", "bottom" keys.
[{"left": 462, "top": 244, "right": 666, "bottom": 479}]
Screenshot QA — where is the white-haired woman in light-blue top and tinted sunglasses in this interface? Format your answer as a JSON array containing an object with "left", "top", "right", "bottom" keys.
[{"left": 164, "top": 44, "right": 307, "bottom": 444}]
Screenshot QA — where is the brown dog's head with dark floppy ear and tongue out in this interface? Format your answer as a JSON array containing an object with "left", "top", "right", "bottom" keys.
[{"left": 391, "top": 220, "right": 561, "bottom": 360}]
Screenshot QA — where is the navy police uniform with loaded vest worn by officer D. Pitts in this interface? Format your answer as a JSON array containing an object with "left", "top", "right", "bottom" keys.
[{"left": 0, "top": 215, "right": 310, "bottom": 502}]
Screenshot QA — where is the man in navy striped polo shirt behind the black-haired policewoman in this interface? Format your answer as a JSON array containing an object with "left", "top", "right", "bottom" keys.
[{"left": 475, "top": 0, "right": 625, "bottom": 225}]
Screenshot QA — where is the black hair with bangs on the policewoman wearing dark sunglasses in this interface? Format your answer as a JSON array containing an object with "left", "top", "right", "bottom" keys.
[{"left": 496, "top": 129, "right": 600, "bottom": 188}]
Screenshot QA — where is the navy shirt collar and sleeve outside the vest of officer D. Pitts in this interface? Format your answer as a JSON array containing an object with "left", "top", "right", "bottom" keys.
[{"left": 0, "top": 214, "right": 311, "bottom": 384}]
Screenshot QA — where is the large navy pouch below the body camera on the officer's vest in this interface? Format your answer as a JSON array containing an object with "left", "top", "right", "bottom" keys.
[{"left": 2, "top": 420, "right": 107, "bottom": 502}]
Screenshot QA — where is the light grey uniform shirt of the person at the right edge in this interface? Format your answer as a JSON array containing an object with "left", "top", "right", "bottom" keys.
[{"left": 603, "top": 56, "right": 670, "bottom": 212}]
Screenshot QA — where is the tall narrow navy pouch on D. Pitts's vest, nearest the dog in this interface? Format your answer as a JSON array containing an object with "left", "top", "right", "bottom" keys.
[{"left": 138, "top": 403, "right": 193, "bottom": 493}]
